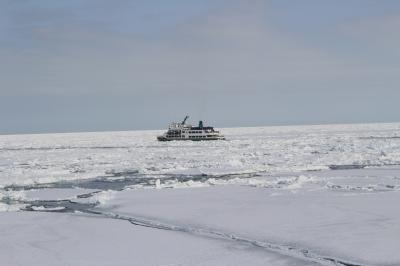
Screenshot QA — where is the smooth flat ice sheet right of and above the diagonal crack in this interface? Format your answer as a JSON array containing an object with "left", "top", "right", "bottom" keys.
[{"left": 99, "top": 186, "right": 400, "bottom": 265}]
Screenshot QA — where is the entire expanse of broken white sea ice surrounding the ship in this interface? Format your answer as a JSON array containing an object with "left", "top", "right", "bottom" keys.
[{"left": 0, "top": 123, "right": 400, "bottom": 266}]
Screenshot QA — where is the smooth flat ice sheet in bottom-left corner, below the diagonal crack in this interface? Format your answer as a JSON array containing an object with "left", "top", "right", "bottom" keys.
[{"left": 0, "top": 212, "right": 311, "bottom": 266}]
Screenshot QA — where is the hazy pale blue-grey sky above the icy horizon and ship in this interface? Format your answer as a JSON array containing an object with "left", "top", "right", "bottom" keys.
[{"left": 0, "top": 0, "right": 400, "bottom": 134}]
